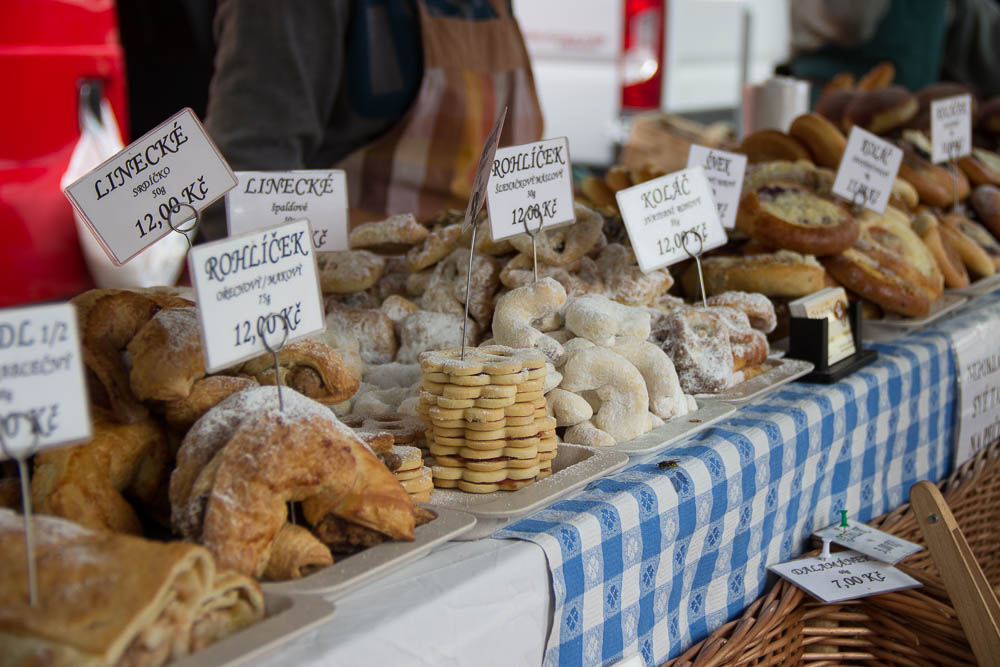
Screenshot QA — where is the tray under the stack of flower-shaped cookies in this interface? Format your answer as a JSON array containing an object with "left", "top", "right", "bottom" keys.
[{"left": 431, "top": 443, "right": 628, "bottom": 539}]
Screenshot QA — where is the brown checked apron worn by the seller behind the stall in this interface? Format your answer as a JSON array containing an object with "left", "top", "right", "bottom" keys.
[{"left": 335, "top": 0, "right": 542, "bottom": 226}]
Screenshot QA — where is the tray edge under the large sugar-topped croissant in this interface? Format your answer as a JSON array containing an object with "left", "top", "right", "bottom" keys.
[{"left": 261, "top": 505, "right": 476, "bottom": 601}]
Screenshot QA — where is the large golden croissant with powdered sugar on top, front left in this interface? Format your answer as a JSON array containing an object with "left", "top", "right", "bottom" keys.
[{"left": 170, "top": 387, "right": 414, "bottom": 577}]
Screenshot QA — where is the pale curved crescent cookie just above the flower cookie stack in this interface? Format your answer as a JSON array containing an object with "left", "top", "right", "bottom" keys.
[{"left": 493, "top": 278, "right": 566, "bottom": 366}]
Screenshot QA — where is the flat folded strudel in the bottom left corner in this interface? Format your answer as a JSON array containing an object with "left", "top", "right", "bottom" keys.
[{"left": 0, "top": 510, "right": 264, "bottom": 667}]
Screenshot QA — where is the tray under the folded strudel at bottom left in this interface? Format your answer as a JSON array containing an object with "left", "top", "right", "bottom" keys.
[{"left": 170, "top": 591, "right": 336, "bottom": 667}]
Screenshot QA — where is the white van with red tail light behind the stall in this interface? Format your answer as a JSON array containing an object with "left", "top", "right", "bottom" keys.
[{"left": 513, "top": 0, "right": 789, "bottom": 166}]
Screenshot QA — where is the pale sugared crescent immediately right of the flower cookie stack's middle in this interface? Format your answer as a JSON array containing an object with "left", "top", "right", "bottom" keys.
[{"left": 562, "top": 346, "right": 650, "bottom": 442}]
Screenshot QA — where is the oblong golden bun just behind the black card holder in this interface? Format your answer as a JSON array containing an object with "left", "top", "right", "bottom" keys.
[{"left": 682, "top": 250, "right": 827, "bottom": 299}]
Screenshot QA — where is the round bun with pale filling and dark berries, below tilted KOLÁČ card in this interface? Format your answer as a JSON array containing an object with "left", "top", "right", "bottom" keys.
[{"left": 740, "top": 182, "right": 858, "bottom": 255}]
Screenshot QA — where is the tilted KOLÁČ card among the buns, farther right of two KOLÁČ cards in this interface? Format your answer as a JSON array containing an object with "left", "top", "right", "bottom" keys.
[{"left": 833, "top": 125, "right": 903, "bottom": 213}]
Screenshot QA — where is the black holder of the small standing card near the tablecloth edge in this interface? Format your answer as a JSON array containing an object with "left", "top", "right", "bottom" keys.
[{"left": 787, "top": 300, "right": 878, "bottom": 384}]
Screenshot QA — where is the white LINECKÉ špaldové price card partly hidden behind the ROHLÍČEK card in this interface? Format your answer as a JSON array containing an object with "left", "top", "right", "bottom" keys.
[{"left": 226, "top": 169, "right": 350, "bottom": 251}]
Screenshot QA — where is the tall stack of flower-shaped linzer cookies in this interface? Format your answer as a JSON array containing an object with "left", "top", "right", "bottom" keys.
[{"left": 410, "top": 345, "right": 556, "bottom": 493}]
